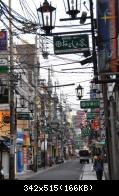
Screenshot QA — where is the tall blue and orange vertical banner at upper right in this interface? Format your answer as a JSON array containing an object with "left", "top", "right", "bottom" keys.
[{"left": 97, "top": 0, "right": 118, "bottom": 73}]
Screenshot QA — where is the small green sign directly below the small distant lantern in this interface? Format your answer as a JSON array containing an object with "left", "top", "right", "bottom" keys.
[{"left": 80, "top": 100, "right": 100, "bottom": 109}]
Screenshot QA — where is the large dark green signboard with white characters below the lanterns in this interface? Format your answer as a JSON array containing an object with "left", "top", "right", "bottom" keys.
[{"left": 53, "top": 34, "right": 89, "bottom": 54}]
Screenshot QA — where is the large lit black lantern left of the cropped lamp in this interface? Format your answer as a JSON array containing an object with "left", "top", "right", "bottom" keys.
[{"left": 37, "top": 0, "right": 56, "bottom": 35}]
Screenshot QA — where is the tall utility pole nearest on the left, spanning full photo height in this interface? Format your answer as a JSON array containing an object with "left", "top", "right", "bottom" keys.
[{"left": 9, "top": 0, "right": 16, "bottom": 180}]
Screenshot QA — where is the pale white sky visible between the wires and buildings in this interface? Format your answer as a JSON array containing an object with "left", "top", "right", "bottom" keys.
[{"left": 0, "top": 0, "right": 93, "bottom": 111}]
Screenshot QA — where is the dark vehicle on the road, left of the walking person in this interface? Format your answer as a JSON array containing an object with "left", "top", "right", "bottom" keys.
[{"left": 79, "top": 150, "right": 90, "bottom": 163}]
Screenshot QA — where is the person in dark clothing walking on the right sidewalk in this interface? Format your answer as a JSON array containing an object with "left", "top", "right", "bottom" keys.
[{"left": 93, "top": 155, "right": 104, "bottom": 180}]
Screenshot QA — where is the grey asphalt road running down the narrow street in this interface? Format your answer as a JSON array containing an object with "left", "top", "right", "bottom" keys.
[{"left": 27, "top": 159, "right": 83, "bottom": 180}]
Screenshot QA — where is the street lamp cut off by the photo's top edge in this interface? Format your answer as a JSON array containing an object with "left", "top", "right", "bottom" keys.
[{"left": 64, "top": 0, "right": 81, "bottom": 19}]
